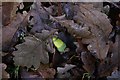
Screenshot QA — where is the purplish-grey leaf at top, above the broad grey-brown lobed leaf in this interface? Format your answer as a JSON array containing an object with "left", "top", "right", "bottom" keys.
[{"left": 30, "top": 1, "right": 51, "bottom": 33}]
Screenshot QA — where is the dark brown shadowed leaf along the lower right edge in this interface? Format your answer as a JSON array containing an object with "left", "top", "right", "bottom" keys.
[{"left": 98, "top": 35, "right": 120, "bottom": 77}]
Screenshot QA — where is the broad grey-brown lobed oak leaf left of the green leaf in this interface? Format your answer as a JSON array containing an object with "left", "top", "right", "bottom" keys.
[{"left": 13, "top": 31, "right": 54, "bottom": 68}]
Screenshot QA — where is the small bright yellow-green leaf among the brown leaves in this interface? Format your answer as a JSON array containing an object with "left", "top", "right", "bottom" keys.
[{"left": 52, "top": 37, "right": 66, "bottom": 52}]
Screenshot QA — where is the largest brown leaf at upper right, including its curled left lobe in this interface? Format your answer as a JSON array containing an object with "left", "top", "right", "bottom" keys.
[{"left": 59, "top": 4, "right": 112, "bottom": 60}]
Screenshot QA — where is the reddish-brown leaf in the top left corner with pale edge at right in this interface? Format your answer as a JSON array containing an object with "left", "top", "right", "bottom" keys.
[{"left": 2, "top": 2, "right": 18, "bottom": 25}]
